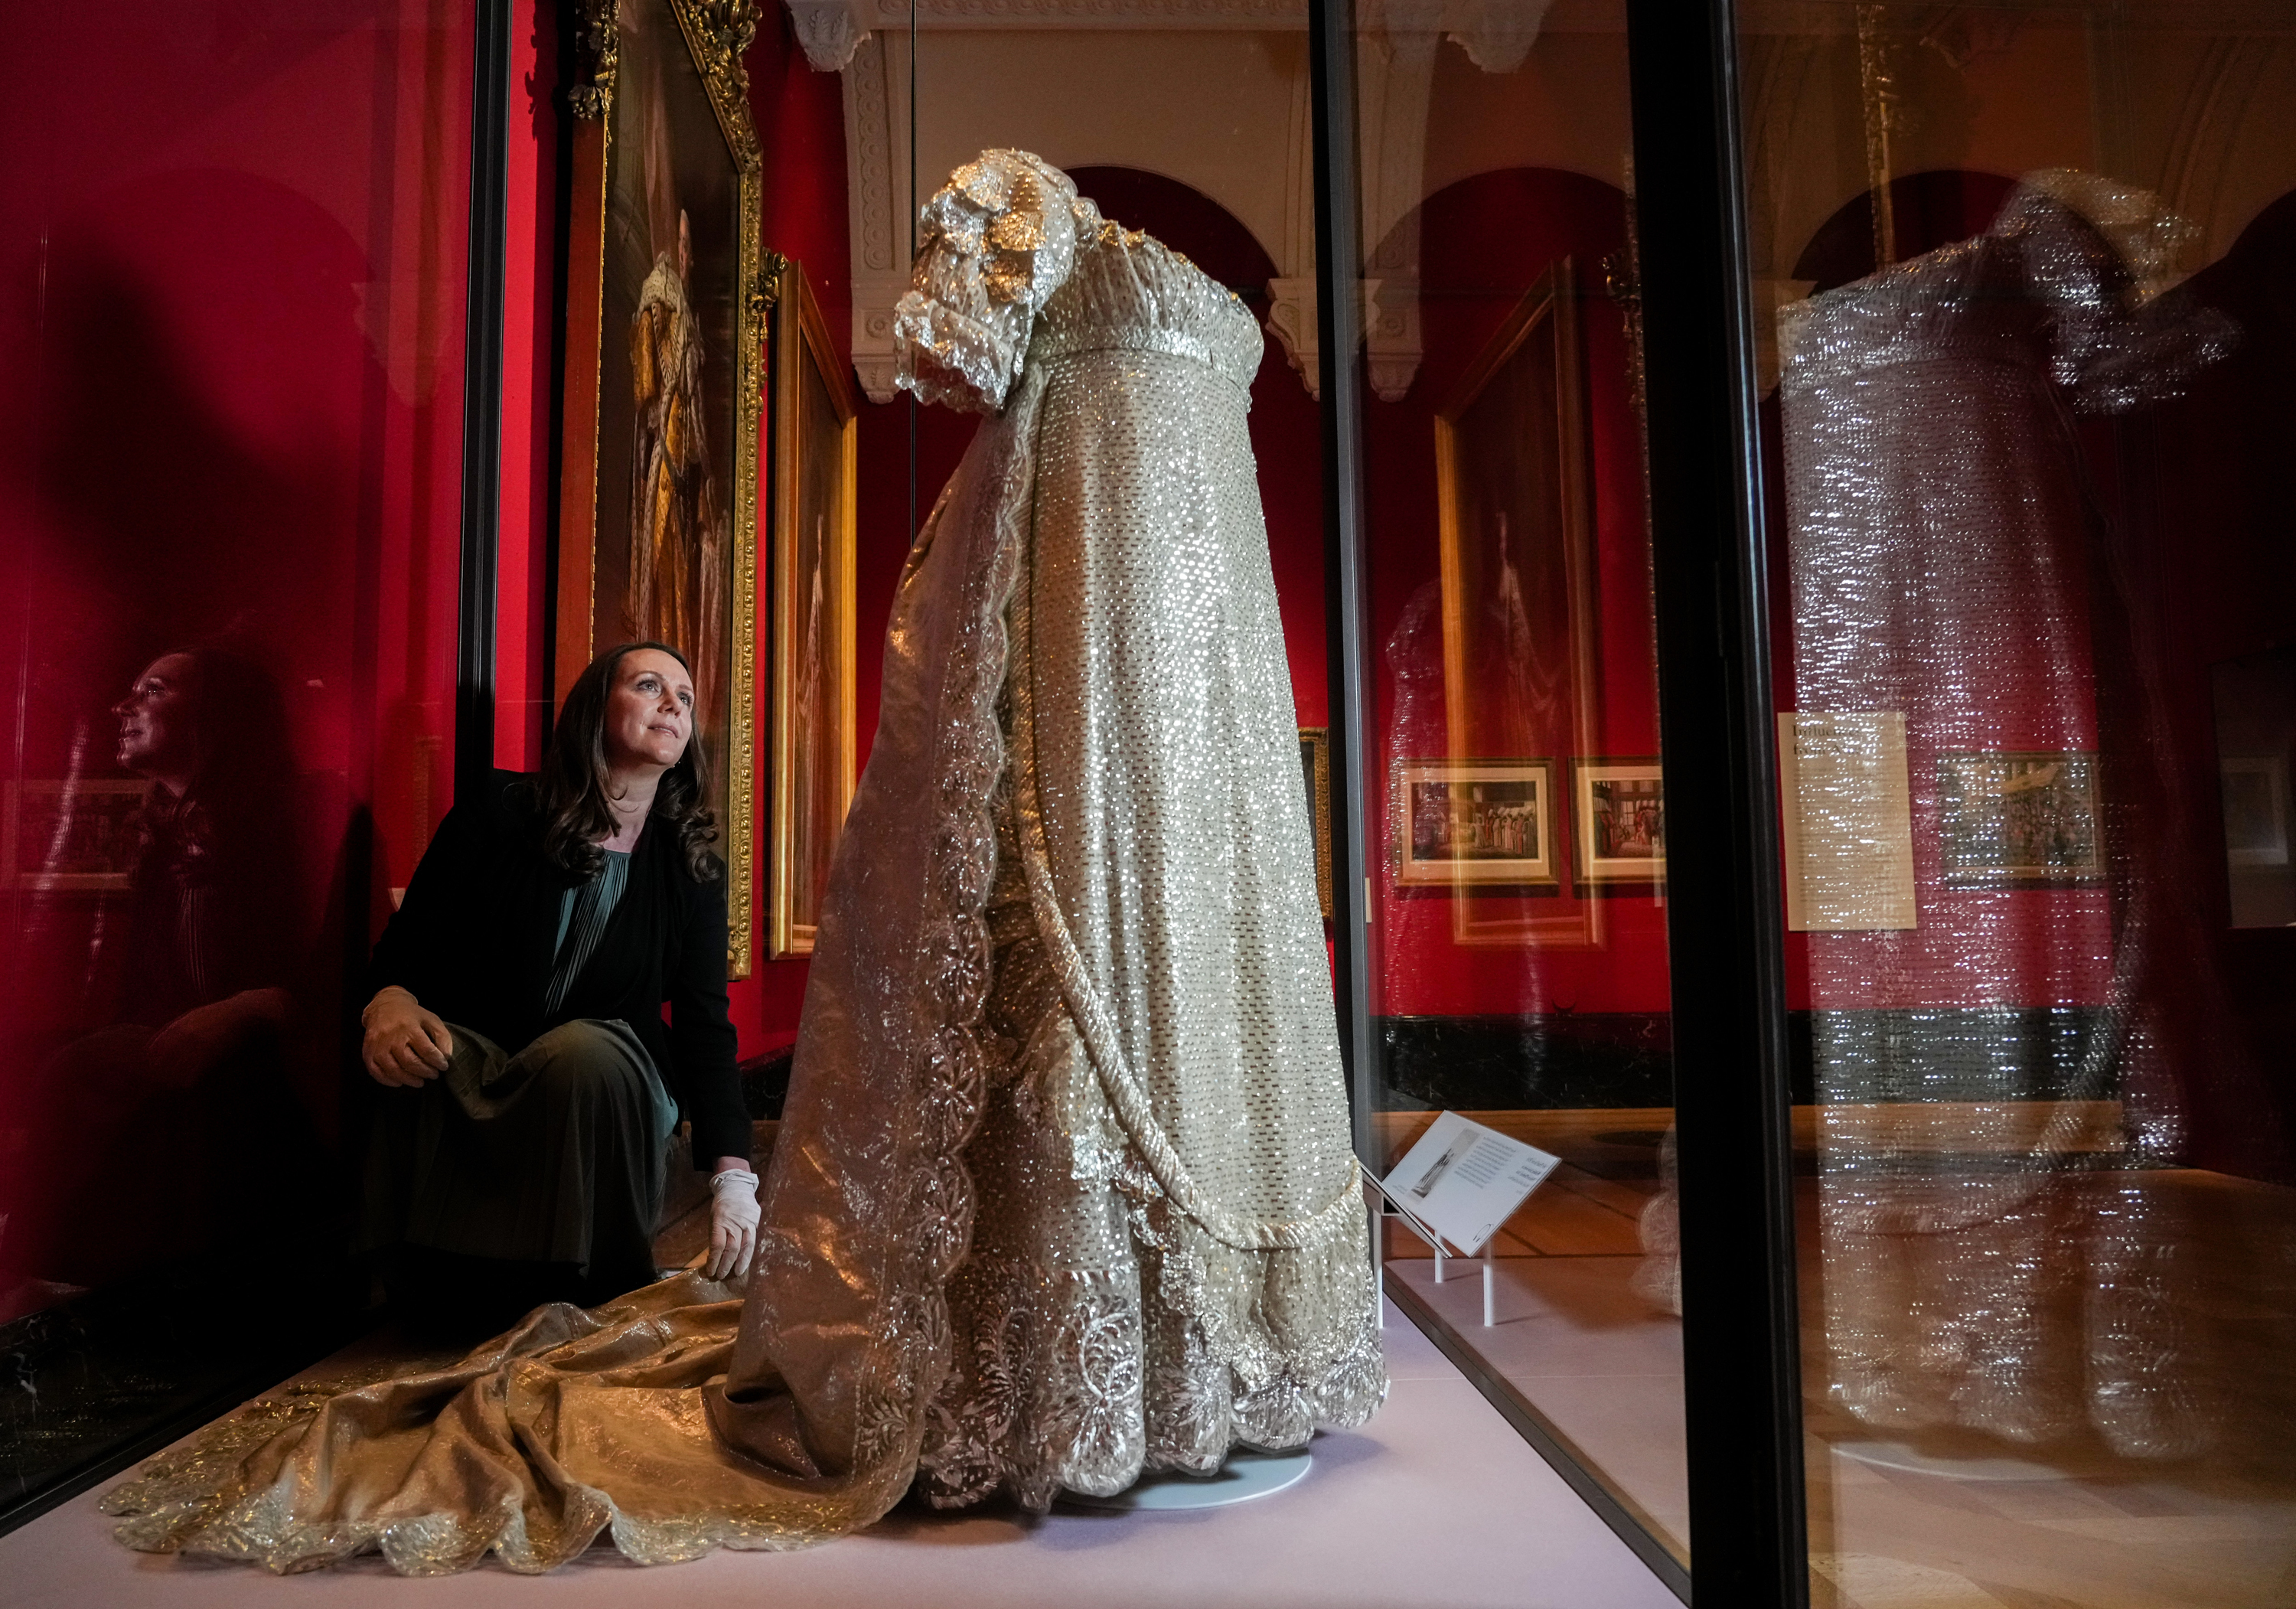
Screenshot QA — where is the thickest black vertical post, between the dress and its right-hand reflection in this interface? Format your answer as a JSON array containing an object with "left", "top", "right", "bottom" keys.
[{"left": 1626, "top": 0, "right": 1809, "bottom": 1609}]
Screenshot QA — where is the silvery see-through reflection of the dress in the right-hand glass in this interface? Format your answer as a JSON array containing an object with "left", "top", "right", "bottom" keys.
[{"left": 1782, "top": 172, "right": 2234, "bottom": 1455}]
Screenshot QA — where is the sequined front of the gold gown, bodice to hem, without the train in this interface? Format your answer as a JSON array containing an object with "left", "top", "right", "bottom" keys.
[{"left": 905, "top": 152, "right": 1384, "bottom": 1506}]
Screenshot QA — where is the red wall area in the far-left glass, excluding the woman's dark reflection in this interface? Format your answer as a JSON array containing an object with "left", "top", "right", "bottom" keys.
[{"left": 0, "top": 0, "right": 471, "bottom": 1276}]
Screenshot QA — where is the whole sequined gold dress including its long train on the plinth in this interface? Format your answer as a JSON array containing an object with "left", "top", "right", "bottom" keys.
[{"left": 108, "top": 152, "right": 1387, "bottom": 1575}]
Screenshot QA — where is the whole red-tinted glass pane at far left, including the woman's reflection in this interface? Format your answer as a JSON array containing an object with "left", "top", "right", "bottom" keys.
[{"left": 0, "top": 0, "right": 471, "bottom": 1506}]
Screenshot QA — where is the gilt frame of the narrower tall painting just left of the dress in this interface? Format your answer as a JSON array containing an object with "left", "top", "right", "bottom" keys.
[{"left": 765, "top": 259, "right": 861, "bottom": 959}]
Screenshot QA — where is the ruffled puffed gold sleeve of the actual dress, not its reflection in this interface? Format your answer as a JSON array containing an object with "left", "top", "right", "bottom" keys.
[{"left": 893, "top": 152, "right": 1077, "bottom": 413}]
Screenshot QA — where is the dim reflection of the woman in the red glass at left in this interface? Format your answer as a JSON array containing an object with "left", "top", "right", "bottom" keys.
[{"left": 9, "top": 648, "right": 321, "bottom": 1285}]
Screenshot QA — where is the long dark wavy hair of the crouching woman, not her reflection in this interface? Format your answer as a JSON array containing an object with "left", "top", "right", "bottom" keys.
[{"left": 535, "top": 643, "right": 723, "bottom": 883}]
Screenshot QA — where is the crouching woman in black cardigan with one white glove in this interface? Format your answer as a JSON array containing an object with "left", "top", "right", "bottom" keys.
[{"left": 360, "top": 643, "right": 758, "bottom": 1329}]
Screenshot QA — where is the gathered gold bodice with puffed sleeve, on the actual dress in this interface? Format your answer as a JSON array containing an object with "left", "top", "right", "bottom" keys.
[{"left": 893, "top": 152, "right": 1263, "bottom": 413}]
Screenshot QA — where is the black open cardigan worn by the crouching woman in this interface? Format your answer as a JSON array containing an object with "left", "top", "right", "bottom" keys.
[{"left": 367, "top": 772, "right": 748, "bottom": 1170}]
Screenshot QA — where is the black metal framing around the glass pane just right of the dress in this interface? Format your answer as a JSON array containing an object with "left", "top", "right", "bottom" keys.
[{"left": 1309, "top": 0, "right": 1809, "bottom": 1609}]
